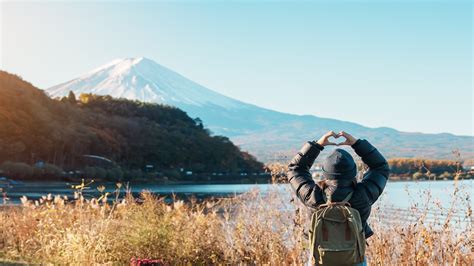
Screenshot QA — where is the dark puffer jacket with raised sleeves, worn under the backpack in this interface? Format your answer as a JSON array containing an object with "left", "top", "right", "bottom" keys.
[{"left": 288, "top": 139, "right": 390, "bottom": 238}]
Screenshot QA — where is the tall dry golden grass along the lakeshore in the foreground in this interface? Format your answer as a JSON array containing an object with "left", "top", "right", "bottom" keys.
[{"left": 0, "top": 178, "right": 473, "bottom": 265}]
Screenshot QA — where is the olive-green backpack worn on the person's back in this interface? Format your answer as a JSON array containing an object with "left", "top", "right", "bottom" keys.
[{"left": 309, "top": 192, "right": 365, "bottom": 265}]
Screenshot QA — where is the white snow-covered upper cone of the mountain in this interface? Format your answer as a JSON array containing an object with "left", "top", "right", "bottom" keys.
[{"left": 47, "top": 57, "right": 243, "bottom": 108}]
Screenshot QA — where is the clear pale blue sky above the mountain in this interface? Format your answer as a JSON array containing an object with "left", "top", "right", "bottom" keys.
[{"left": 0, "top": 1, "right": 474, "bottom": 135}]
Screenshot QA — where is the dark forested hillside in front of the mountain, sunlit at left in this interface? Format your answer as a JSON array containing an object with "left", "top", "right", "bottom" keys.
[{"left": 0, "top": 71, "right": 263, "bottom": 181}]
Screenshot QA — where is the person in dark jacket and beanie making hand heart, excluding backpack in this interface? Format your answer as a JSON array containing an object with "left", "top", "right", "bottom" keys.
[{"left": 287, "top": 131, "right": 390, "bottom": 265}]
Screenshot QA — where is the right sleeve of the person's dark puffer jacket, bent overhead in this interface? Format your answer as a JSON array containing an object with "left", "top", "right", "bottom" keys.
[{"left": 352, "top": 139, "right": 390, "bottom": 204}]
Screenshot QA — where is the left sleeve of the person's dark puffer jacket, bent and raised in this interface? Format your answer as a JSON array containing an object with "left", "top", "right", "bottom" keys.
[{"left": 287, "top": 142, "right": 324, "bottom": 208}]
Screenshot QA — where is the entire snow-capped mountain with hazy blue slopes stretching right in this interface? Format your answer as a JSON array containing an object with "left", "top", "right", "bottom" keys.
[{"left": 46, "top": 57, "right": 474, "bottom": 160}]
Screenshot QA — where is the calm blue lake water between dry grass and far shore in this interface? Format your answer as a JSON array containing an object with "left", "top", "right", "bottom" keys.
[{"left": 2, "top": 180, "right": 473, "bottom": 208}]
